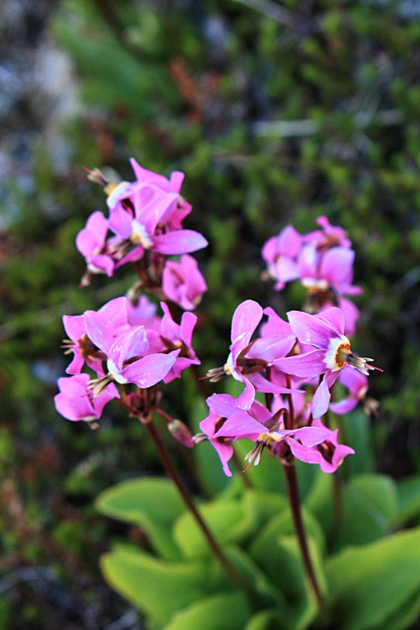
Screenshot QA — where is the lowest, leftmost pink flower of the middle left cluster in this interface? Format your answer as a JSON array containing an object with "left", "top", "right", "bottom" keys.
[{"left": 54, "top": 374, "right": 120, "bottom": 422}]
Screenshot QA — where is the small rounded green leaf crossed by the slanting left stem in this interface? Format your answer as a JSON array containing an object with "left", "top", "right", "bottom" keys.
[{"left": 173, "top": 499, "right": 255, "bottom": 558}]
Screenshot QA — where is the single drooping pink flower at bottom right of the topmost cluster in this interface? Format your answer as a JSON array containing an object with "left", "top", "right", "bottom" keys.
[{"left": 162, "top": 254, "right": 207, "bottom": 311}]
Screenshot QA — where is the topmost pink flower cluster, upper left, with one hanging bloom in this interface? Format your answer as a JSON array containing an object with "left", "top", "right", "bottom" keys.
[{"left": 76, "top": 159, "right": 207, "bottom": 310}]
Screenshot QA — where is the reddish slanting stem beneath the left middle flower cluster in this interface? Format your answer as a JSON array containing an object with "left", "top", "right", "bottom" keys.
[{"left": 143, "top": 422, "right": 249, "bottom": 592}]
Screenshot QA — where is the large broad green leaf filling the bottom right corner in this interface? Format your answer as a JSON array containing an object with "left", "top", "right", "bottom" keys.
[{"left": 327, "top": 528, "right": 420, "bottom": 630}]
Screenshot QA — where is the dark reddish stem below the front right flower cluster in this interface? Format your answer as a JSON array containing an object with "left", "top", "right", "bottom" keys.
[{"left": 283, "top": 463, "right": 328, "bottom": 621}]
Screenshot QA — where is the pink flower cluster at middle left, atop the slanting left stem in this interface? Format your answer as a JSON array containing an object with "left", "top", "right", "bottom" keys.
[{"left": 55, "top": 297, "right": 200, "bottom": 421}]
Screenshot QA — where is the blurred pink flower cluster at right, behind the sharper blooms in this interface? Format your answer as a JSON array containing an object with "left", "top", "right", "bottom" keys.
[{"left": 262, "top": 216, "right": 362, "bottom": 336}]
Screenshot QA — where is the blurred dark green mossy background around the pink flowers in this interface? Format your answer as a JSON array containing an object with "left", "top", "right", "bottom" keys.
[{"left": 0, "top": 0, "right": 420, "bottom": 630}]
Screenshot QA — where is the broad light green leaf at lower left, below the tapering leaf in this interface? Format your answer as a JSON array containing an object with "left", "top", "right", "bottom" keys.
[{"left": 101, "top": 550, "right": 215, "bottom": 626}]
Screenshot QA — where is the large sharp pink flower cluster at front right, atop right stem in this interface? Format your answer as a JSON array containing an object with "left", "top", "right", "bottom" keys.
[{"left": 195, "top": 300, "right": 377, "bottom": 475}]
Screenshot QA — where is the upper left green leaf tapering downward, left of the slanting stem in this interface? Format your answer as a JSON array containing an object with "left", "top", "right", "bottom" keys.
[{"left": 95, "top": 478, "right": 185, "bottom": 560}]
